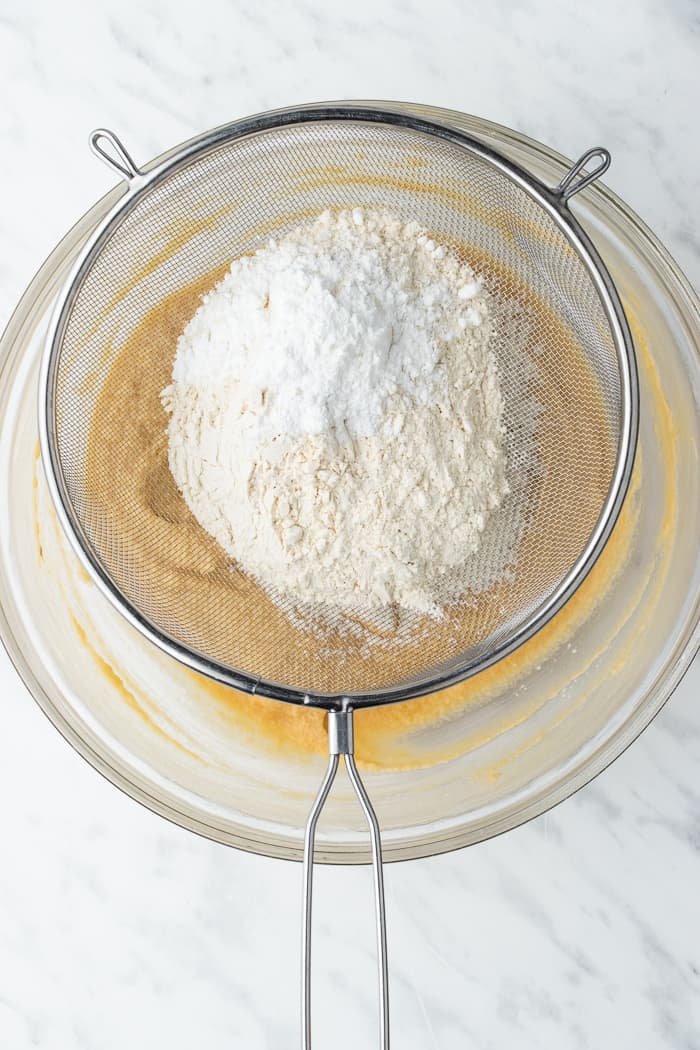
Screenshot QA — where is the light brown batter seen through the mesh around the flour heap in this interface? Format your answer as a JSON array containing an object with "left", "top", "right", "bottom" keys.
[{"left": 86, "top": 241, "right": 613, "bottom": 705}]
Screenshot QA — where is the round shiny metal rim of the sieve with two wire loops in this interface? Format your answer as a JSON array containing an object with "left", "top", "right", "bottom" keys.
[{"left": 39, "top": 105, "right": 639, "bottom": 709}]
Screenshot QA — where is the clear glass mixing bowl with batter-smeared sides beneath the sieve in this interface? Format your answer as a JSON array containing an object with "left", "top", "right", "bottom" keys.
[{"left": 0, "top": 104, "right": 700, "bottom": 863}]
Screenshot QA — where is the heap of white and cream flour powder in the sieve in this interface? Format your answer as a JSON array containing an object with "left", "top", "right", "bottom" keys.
[{"left": 163, "top": 209, "right": 508, "bottom": 616}]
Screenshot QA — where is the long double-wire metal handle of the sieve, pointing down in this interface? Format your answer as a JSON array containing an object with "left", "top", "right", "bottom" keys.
[{"left": 301, "top": 708, "right": 389, "bottom": 1050}]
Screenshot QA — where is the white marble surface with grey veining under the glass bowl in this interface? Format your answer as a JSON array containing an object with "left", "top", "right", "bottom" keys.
[{"left": 0, "top": 0, "right": 700, "bottom": 1050}]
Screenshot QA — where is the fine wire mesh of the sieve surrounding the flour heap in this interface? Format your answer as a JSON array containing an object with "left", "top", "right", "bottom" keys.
[{"left": 47, "top": 119, "right": 623, "bottom": 702}]
